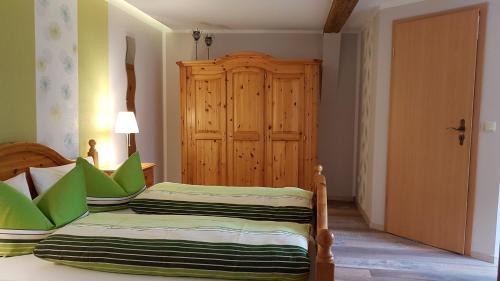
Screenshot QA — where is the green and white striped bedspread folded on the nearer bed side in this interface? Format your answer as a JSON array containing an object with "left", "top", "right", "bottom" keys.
[{"left": 34, "top": 213, "right": 310, "bottom": 280}]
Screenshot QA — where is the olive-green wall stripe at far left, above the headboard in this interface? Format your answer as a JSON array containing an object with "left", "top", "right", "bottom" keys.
[{"left": 0, "top": 0, "right": 36, "bottom": 143}]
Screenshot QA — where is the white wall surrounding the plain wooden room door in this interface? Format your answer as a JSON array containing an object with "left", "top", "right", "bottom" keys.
[{"left": 364, "top": 0, "right": 500, "bottom": 261}]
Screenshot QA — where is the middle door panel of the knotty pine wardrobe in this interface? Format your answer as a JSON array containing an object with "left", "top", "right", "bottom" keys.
[{"left": 227, "top": 67, "right": 266, "bottom": 186}]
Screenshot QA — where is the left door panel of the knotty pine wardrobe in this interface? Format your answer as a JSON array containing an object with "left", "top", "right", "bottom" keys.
[{"left": 185, "top": 73, "right": 226, "bottom": 185}]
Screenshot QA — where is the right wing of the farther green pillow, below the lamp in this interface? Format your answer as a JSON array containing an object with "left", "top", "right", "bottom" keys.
[{"left": 111, "top": 152, "right": 146, "bottom": 194}]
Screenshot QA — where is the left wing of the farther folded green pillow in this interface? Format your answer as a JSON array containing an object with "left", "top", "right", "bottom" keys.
[{"left": 76, "top": 158, "right": 131, "bottom": 212}]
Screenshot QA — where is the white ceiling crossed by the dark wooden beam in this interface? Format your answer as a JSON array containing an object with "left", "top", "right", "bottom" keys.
[{"left": 126, "top": 0, "right": 423, "bottom": 32}]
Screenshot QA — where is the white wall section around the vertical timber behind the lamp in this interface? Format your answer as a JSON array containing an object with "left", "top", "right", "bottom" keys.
[{"left": 108, "top": 2, "right": 163, "bottom": 181}]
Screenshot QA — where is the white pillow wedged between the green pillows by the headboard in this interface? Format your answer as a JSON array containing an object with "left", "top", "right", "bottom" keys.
[{"left": 30, "top": 157, "right": 94, "bottom": 195}]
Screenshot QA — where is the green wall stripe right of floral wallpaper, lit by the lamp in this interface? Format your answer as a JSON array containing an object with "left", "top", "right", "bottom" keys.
[{"left": 78, "top": 0, "right": 111, "bottom": 154}]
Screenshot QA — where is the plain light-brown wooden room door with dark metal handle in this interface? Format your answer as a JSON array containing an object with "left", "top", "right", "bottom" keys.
[{"left": 386, "top": 8, "right": 479, "bottom": 253}]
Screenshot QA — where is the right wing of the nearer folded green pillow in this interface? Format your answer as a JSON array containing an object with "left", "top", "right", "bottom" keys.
[{"left": 34, "top": 165, "right": 88, "bottom": 227}]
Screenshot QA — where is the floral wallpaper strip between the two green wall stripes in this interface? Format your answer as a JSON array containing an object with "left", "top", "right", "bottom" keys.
[{"left": 34, "top": 0, "right": 79, "bottom": 158}]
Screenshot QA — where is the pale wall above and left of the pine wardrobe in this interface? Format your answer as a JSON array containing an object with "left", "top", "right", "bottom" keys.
[{"left": 166, "top": 32, "right": 340, "bottom": 182}]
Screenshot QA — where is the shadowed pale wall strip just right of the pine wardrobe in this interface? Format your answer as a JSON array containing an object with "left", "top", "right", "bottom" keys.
[{"left": 319, "top": 33, "right": 359, "bottom": 201}]
